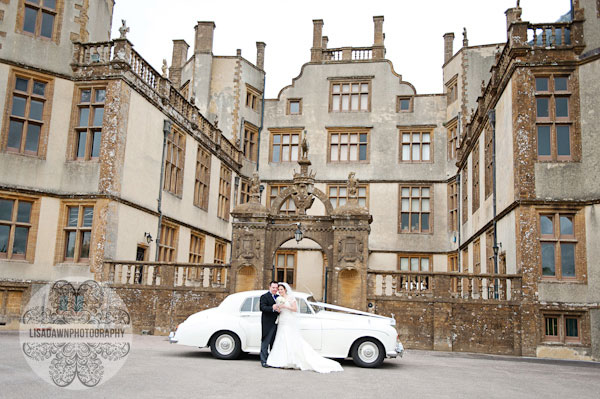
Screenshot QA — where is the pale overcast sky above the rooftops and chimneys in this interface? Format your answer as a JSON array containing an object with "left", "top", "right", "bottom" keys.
[{"left": 112, "top": 0, "right": 570, "bottom": 98}]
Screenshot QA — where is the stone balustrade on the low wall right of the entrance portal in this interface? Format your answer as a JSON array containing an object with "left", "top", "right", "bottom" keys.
[{"left": 367, "top": 270, "right": 521, "bottom": 300}]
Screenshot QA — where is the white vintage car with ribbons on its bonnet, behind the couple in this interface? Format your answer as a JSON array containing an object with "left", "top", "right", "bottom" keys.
[{"left": 169, "top": 291, "right": 404, "bottom": 367}]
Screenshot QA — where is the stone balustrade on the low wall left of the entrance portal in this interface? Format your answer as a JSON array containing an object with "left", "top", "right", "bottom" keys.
[{"left": 103, "top": 261, "right": 231, "bottom": 289}]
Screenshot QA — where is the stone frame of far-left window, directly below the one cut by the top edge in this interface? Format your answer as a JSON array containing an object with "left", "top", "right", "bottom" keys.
[{"left": 0, "top": 68, "right": 54, "bottom": 159}]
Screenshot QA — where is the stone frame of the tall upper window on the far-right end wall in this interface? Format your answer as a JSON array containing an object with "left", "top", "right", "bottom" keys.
[{"left": 533, "top": 71, "right": 577, "bottom": 162}]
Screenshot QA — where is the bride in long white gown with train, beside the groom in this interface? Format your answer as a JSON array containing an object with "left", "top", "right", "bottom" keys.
[{"left": 267, "top": 283, "right": 343, "bottom": 373}]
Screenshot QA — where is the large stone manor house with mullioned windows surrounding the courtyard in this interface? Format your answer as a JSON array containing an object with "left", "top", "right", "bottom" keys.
[{"left": 0, "top": 0, "right": 600, "bottom": 360}]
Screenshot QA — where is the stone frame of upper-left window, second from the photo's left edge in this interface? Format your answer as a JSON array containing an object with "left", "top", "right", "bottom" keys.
[{"left": 67, "top": 83, "right": 108, "bottom": 161}]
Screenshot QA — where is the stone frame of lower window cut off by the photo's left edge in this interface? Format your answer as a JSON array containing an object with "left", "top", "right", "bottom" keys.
[{"left": 0, "top": 192, "right": 40, "bottom": 263}]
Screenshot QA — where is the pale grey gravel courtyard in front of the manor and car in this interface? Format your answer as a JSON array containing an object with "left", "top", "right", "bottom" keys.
[{"left": 0, "top": 332, "right": 600, "bottom": 399}]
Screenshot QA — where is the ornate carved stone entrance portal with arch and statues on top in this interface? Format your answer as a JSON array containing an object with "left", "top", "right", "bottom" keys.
[{"left": 231, "top": 149, "right": 373, "bottom": 309}]
